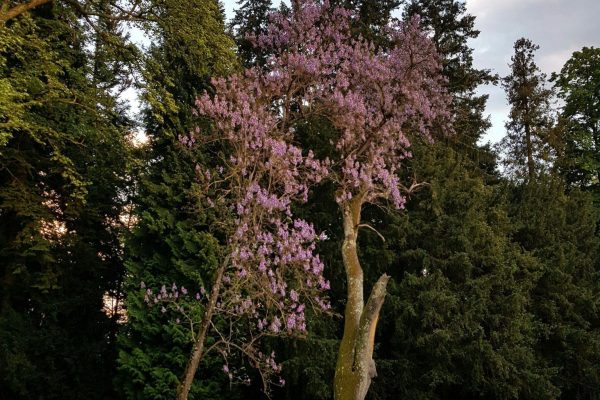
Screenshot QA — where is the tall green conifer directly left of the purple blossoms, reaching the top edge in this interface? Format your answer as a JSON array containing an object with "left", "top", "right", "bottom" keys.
[{"left": 118, "top": 0, "right": 241, "bottom": 399}]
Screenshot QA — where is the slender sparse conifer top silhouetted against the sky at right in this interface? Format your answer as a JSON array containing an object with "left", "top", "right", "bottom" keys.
[{"left": 499, "top": 38, "right": 553, "bottom": 180}]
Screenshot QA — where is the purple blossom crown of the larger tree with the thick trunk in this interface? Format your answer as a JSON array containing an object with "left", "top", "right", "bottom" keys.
[{"left": 254, "top": 1, "right": 449, "bottom": 208}]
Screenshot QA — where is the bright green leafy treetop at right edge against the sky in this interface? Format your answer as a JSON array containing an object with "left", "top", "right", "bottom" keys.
[{"left": 553, "top": 47, "right": 600, "bottom": 202}]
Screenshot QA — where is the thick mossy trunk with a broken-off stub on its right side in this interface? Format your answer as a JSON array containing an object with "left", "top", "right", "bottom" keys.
[{"left": 334, "top": 196, "right": 389, "bottom": 400}]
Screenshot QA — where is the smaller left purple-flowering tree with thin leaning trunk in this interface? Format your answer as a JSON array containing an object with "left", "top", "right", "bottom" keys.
[{"left": 171, "top": 70, "right": 329, "bottom": 399}]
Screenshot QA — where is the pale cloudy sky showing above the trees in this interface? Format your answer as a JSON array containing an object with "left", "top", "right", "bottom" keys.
[{"left": 223, "top": 0, "right": 600, "bottom": 142}]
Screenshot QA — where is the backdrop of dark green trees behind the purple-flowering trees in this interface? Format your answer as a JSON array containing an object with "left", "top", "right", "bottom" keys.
[{"left": 0, "top": 0, "right": 600, "bottom": 400}]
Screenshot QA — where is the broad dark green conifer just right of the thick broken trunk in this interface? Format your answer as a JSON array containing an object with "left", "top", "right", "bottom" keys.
[{"left": 372, "top": 145, "right": 557, "bottom": 399}]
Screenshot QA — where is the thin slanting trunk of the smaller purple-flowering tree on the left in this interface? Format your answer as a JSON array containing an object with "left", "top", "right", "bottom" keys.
[{"left": 177, "top": 257, "right": 229, "bottom": 400}]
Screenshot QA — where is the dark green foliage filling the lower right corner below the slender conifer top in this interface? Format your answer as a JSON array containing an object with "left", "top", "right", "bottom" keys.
[{"left": 512, "top": 176, "right": 600, "bottom": 399}]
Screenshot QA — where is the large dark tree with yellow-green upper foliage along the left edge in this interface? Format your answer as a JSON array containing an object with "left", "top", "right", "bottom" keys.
[{"left": 0, "top": 2, "right": 129, "bottom": 399}]
